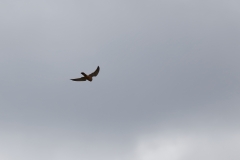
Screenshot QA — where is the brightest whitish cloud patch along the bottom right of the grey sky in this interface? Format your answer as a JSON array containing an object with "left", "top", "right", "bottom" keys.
[{"left": 135, "top": 131, "right": 240, "bottom": 160}]
